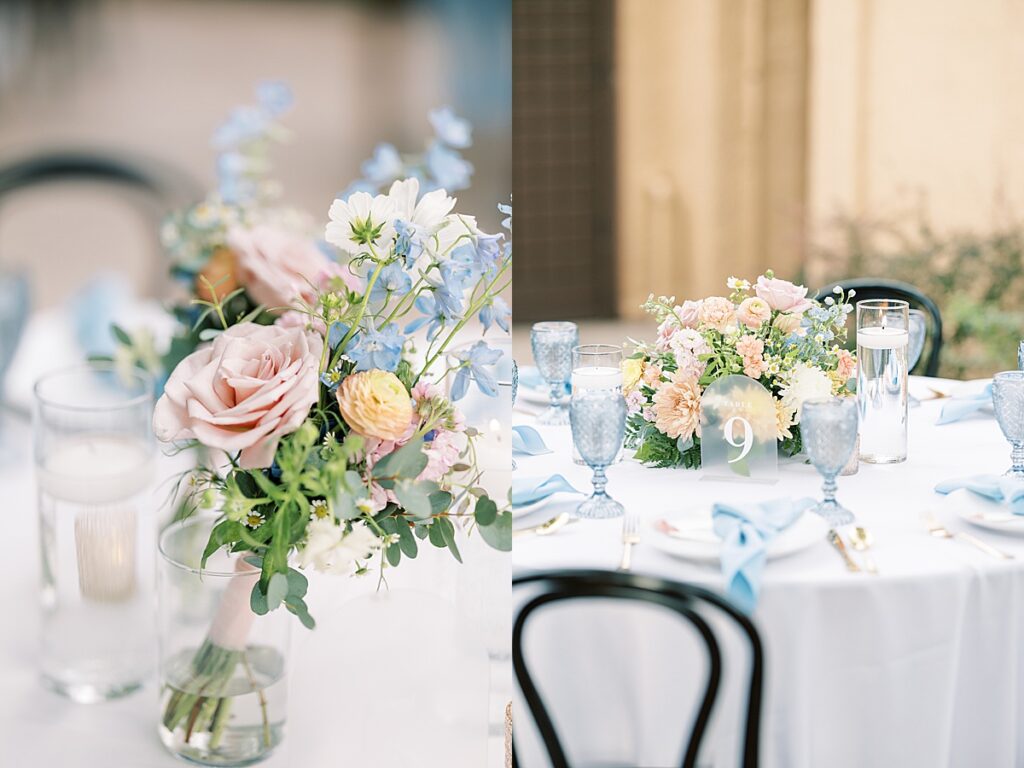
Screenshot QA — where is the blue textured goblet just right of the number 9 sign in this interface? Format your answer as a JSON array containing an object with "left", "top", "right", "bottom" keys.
[{"left": 800, "top": 397, "right": 857, "bottom": 527}]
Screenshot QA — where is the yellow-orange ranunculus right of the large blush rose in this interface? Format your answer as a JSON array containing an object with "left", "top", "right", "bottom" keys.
[{"left": 338, "top": 369, "right": 413, "bottom": 440}]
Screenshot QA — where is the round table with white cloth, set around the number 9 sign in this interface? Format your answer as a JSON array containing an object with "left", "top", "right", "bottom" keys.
[{"left": 514, "top": 379, "right": 1024, "bottom": 768}]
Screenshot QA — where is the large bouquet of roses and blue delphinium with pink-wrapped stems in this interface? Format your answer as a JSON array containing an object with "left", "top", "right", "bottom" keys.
[{"left": 142, "top": 82, "right": 511, "bottom": 757}]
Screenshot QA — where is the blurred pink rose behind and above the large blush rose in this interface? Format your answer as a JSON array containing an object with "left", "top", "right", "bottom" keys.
[{"left": 227, "top": 224, "right": 360, "bottom": 309}]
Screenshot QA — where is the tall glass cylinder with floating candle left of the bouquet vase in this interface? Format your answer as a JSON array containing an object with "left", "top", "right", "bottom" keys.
[{"left": 33, "top": 362, "right": 158, "bottom": 701}]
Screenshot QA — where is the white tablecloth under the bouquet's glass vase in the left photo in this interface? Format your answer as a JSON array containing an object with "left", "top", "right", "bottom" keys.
[{"left": 0, "top": 416, "right": 512, "bottom": 768}]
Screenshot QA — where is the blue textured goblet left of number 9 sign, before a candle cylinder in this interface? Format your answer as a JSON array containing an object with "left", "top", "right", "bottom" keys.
[{"left": 569, "top": 389, "right": 626, "bottom": 518}]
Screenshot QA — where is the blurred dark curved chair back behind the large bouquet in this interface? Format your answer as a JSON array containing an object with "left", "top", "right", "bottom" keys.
[{"left": 0, "top": 150, "right": 205, "bottom": 294}]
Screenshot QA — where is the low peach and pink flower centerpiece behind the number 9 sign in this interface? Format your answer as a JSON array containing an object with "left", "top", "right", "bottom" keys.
[{"left": 624, "top": 270, "right": 856, "bottom": 469}]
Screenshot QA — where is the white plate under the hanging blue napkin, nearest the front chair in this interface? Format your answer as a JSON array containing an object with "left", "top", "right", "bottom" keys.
[{"left": 647, "top": 506, "right": 828, "bottom": 564}]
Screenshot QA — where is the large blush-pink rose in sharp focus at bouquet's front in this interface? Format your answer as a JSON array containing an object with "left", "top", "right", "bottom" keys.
[{"left": 153, "top": 323, "right": 324, "bottom": 469}]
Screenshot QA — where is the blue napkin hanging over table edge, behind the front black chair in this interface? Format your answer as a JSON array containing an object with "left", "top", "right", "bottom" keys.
[{"left": 711, "top": 499, "right": 815, "bottom": 613}]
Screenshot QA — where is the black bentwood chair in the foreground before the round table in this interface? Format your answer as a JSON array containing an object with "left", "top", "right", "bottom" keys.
[{"left": 512, "top": 570, "right": 764, "bottom": 768}]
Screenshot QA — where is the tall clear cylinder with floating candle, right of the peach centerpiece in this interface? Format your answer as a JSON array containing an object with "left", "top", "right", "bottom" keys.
[{"left": 857, "top": 299, "right": 910, "bottom": 464}]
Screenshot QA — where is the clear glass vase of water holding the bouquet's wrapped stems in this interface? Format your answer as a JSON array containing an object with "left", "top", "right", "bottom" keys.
[{"left": 157, "top": 516, "right": 294, "bottom": 766}]
